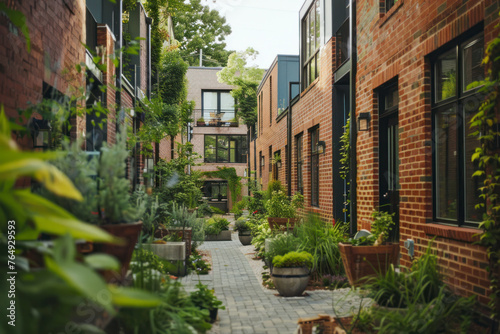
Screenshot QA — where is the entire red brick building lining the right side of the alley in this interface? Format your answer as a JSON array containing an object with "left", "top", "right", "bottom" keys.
[{"left": 256, "top": 0, "right": 500, "bottom": 303}]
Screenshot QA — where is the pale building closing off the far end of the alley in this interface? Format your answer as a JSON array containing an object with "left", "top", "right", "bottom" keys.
[{"left": 186, "top": 67, "right": 248, "bottom": 211}]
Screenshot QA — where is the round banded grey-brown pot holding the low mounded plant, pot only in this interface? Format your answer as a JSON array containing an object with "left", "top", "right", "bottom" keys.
[{"left": 272, "top": 267, "right": 310, "bottom": 297}]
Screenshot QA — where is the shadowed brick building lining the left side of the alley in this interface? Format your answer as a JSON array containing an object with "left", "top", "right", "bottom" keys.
[{"left": 0, "top": 0, "right": 160, "bottom": 190}]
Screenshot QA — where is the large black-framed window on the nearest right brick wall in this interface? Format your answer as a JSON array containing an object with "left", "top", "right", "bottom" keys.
[{"left": 433, "top": 34, "right": 484, "bottom": 226}]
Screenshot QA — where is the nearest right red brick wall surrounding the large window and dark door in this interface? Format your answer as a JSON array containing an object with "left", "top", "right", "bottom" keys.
[{"left": 356, "top": 0, "right": 498, "bottom": 302}]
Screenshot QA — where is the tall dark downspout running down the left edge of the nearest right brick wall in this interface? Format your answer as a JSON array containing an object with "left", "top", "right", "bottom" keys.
[{"left": 349, "top": 0, "right": 358, "bottom": 235}]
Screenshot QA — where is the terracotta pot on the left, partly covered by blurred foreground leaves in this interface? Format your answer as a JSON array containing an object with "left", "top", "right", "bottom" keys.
[{"left": 95, "top": 222, "right": 142, "bottom": 282}]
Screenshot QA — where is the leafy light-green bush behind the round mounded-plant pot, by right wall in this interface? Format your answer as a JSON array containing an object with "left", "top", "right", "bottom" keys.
[{"left": 265, "top": 190, "right": 304, "bottom": 230}]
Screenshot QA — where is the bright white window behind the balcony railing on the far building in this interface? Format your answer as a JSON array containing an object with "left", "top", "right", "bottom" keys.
[{"left": 202, "top": 91, "right": 236, "bottom": 122}]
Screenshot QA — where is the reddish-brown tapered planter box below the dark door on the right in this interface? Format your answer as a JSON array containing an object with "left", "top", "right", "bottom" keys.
[{"left": 339, "top": 243, "right": 399, "bottom": 286}]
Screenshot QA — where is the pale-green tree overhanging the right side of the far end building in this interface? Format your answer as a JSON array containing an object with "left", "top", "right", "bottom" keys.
[{"left": 217, "top": 48, "right": 265, "bottom": 128}]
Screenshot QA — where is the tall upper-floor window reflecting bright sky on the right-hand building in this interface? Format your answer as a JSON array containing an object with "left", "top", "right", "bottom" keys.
[{"left": 302, "top": 0, "right": 321, "bottom": 88}]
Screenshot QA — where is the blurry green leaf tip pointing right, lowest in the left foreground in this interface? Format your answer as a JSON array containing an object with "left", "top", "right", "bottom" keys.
[{"left": 109, "top": 285, "right": 162, "bottom": 308}]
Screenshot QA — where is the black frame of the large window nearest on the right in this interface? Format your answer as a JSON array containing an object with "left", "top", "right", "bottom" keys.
[{"left": 429, "top": 28, "right": 485, "bottom": 228}]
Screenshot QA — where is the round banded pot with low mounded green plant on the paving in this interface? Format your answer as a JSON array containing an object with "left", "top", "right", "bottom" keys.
[{"left": 272, "top": 252, "right": 313, "bottom": 297}]
